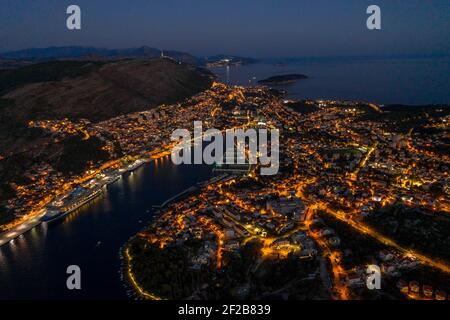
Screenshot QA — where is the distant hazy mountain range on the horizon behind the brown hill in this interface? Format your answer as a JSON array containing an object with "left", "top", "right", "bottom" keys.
[{"left": 0, "top": 46, "right": 256, "bottom": 69}]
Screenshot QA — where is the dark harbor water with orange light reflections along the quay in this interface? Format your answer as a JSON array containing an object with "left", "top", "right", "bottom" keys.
[{"left": 0, "top": 159, "right": 212, "bottom": 299}]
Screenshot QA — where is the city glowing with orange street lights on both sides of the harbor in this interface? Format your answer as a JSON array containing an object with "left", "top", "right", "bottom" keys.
[{"left": 2, "top": 82, "right": 450, "bottom": 299}]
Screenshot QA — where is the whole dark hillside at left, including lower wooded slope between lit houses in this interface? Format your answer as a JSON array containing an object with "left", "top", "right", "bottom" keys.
[{"left": 0, "top": 58, "right": 214, "bottom": 208}]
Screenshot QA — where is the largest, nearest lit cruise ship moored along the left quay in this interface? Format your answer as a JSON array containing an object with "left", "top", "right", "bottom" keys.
[{"left": 41, "top": 187, "right": 102, "bottom": 222}]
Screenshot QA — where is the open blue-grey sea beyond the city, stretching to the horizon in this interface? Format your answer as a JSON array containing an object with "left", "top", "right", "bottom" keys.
[{"left": 209, "top": 56, "right": 450, "bottom": 106}]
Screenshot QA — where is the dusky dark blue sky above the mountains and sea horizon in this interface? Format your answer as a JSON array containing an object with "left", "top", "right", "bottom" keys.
[{"left": 0, "top": 0, "right": 450, "bottom": 57}]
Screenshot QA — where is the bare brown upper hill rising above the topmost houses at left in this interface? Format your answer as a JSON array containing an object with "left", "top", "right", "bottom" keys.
[{"left": 0, "top": 58, "right": 212, "bottom": 123}]
